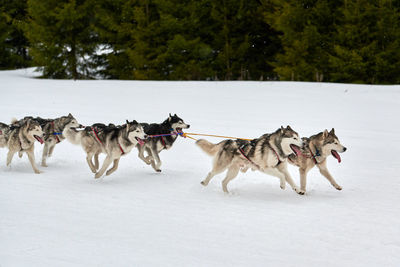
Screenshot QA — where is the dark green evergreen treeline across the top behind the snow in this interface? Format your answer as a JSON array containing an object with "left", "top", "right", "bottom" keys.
[{"left": 0, "top": 0, "right": 400, "bottom": 84}]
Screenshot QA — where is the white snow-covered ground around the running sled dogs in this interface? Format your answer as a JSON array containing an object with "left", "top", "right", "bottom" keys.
[{"left": 0, "top": 69, "right": 400, "bottom": 267}]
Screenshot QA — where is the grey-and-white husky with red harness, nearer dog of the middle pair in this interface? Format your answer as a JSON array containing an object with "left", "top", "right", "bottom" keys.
[{"left": 63, "top": 121, "right": 147, "bottom": 178}]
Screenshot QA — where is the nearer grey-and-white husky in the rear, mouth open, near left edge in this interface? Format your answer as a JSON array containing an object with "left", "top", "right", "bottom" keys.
[{"left": 7, "top": 119, "right": 43, "bottom": 173}]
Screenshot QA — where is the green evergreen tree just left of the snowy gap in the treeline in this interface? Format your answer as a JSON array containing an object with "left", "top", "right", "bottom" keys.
[{"left": 25, "top": 0, "right": 97, "bottom": 79}]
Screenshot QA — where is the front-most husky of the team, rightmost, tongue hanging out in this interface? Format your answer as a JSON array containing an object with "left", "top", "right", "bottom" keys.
[{"left": 289, "top": 128, "right": 347, "bottom": 192}]
